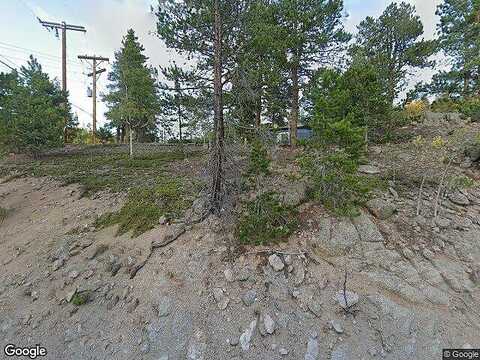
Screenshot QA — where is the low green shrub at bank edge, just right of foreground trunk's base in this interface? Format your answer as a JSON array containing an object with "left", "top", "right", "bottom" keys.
[{"left": 237, "top": 192, "right": 297, "bottom": 245}]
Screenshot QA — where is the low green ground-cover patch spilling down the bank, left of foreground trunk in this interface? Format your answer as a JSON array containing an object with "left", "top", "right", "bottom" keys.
[{"left": 95, "top": 178, "right": 195, "bottom": 237}]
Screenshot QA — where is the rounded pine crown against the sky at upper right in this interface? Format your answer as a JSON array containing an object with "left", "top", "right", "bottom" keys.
[{"left": 351, "top": 2, "right": 435, "bottom": 104}]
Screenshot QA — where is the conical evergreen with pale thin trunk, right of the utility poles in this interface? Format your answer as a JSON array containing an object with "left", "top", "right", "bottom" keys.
[{"left": 104, "top": 29, "right": 159, "bottom": 156}]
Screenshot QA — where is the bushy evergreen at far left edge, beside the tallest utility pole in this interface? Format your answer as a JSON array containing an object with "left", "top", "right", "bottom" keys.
[{"left": 0, "top": 56, "right": 72, "bottom": 156}]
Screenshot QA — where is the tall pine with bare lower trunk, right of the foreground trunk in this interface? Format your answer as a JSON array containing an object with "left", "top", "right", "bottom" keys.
[{"left": 277, "top": 0, "right": 350, "bottom": 146}]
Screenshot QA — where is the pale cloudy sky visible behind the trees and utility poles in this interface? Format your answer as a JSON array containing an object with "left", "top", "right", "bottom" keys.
[{"left": 0, "top": 0, "right": 441, "bottom": 127}]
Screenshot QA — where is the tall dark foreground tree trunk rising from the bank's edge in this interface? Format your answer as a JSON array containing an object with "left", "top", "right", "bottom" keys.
[{"left": 210, "top": 0, "right": 225, "bottom": 213}]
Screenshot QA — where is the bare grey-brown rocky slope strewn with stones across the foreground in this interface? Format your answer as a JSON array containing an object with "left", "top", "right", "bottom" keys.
[{"left": 0, "top": 116, "right": 480, "bottom": 360}]
